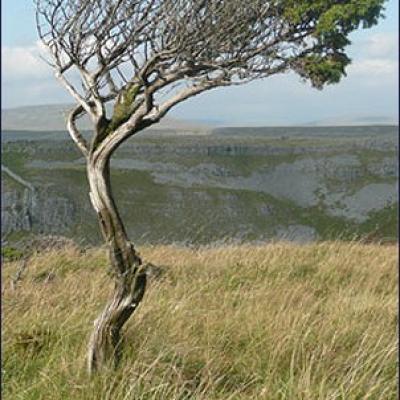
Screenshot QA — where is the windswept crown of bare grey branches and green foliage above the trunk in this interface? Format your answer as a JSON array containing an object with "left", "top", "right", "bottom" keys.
[{"left": 36, "top": 0, "right": 383, "bottom": 159}]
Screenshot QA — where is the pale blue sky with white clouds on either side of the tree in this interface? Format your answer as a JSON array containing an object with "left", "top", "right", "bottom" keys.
[{"left": 1, "top": 0, "right": 399, "bottom": 126}]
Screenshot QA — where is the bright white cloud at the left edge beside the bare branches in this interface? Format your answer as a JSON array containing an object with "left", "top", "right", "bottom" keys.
[{"left": 1, "top": 44, "right": 51, "bottom": 81}]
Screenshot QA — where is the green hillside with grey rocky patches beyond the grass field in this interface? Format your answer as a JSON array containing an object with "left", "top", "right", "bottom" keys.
[{"left": 2, "top": 126, "right": 398, "bottom": 244}]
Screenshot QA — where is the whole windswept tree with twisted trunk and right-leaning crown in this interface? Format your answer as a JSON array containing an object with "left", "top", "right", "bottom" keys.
[{"left": 35, "top": 0, "right": 384, "bottom": 372}]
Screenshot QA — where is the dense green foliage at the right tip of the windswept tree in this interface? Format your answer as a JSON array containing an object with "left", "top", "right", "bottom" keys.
[{"left": 281, "top": 0, "right": 385, "bottom": 89}]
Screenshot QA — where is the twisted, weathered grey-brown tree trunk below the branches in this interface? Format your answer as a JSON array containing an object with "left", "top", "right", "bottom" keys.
[{"left": 87, "top": 159, "right": 146, "bottom": 374}]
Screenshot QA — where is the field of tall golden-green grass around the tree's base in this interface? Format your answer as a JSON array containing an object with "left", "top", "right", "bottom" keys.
[{"left": 2, "top": 242, "right": 398, "bottom": 400}]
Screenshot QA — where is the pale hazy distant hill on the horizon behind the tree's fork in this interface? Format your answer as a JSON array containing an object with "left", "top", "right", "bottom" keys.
[{"left": 1, "top": 104, "right": 210, "bottom": 134}]
